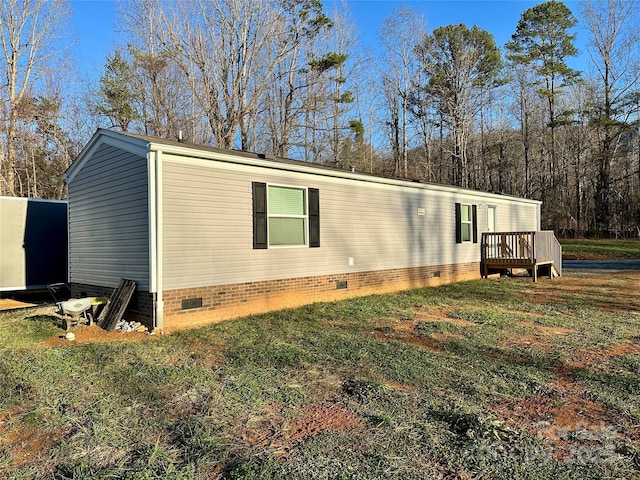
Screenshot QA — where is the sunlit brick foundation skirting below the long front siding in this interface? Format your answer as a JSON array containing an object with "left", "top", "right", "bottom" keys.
[{"left": 163, "top": 262, "right": 480, "bottom": 331}]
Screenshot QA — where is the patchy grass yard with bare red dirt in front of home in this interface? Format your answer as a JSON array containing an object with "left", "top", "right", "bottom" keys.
[{"left": 0, "top": 272, "right": 640, "bottom": 480}]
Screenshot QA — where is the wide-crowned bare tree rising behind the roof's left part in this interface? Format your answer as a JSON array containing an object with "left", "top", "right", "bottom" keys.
[{"left": 157, "top": 0, "right": 293, "bottom": 149}]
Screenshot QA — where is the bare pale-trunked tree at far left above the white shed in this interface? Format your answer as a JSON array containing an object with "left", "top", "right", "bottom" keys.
[{"left": 0, "top": 0, "right": 69, "bottom": 195}]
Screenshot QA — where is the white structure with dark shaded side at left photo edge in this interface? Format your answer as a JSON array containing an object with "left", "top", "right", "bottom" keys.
[{"left": 0, "top": 197, "right": 67, "bottom": 292}]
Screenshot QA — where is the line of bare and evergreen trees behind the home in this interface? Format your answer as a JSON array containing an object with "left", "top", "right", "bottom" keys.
[{"left": 0, "top": 0, "right": 640, "bottom": 236}]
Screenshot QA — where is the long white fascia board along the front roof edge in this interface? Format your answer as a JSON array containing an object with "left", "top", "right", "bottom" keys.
[{"left": 150, "top": 139, "right": 542, "bottom": 205}]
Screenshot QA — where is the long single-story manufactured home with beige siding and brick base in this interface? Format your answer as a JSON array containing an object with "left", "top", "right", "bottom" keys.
[{"left": 65, "top": 130, "right": 552, "bottom": 330}]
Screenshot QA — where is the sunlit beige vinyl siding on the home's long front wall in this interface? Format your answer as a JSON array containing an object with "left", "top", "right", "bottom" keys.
[{"left": 162, "top": 155, "right": 537, "bottom": 289}]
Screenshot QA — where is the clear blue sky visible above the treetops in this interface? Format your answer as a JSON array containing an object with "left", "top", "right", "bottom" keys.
[{"left": 70, "top": 0, "right": 584, "bottom": 77}]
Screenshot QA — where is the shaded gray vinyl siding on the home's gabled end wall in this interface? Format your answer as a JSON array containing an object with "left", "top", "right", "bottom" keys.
[{"left": 69, "top": 144, "right": 149, "bottom": 291}]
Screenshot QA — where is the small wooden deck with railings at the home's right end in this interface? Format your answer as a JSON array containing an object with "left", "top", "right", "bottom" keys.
[{"left": 481, "top": 231, "right": 562, "bottom": 282}]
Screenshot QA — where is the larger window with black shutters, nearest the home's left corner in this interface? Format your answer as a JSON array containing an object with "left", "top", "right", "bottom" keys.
[{"left": 253, "top": 182, "right": 320, "bottom": 249}]
